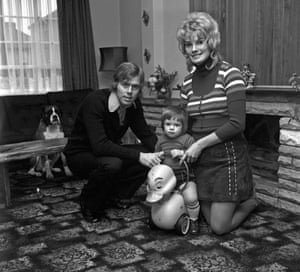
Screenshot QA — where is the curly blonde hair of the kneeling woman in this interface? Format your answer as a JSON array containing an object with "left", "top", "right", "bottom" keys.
[{"left": 176, "top": 12, "right": 221, "bottom": 70}]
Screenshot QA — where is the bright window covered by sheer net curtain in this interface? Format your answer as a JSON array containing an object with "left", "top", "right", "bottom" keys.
[{"left": 0, "top": 0, "right": 62, "bottom": 95}]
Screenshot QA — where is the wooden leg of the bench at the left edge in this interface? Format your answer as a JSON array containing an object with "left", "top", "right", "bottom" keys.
[{"left": 0, "top": 163, "right": 11, "bottom": 208}]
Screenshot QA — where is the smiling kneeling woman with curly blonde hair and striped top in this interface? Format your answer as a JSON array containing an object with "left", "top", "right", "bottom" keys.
[{"left": 177, "top": 12, "right": 257, "bottom": 234}]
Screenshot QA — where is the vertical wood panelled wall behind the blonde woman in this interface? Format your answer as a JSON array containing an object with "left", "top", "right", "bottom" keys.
[{"left": 190, "top": 0, "right": 300, "bottom": 85}]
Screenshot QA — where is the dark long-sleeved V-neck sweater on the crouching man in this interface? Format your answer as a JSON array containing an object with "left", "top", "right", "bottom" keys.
[{"left": 64, "top": 89, "right": 157, "bottom": 160}]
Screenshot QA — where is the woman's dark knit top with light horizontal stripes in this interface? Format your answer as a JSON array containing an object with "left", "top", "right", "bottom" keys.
[{"left": 181, "top": 61, "right": 246, "bottom": 141}]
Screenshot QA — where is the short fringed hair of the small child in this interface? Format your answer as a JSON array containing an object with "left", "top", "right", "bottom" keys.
[{"left": 161, "top": 106, "right": 188, "bottom": 133}]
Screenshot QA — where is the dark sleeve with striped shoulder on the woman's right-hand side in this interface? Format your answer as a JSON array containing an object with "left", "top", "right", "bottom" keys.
[{"left": 216, "top": 65, "right": 246, "bottom": 141}]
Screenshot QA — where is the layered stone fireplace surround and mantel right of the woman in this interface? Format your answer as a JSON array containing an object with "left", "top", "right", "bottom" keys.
[{"left": 246, "top": 86, "right": 300, "bottom": 213}]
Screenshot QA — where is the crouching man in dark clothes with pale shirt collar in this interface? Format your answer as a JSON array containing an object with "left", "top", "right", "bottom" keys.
[{"left": 64, "top": 62, "right": 161, "bottom": 222}]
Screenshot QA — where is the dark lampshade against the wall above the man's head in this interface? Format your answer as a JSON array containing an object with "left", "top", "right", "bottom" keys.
[{"left": 99, "top": 46, "right": 127, "bottom": 71}]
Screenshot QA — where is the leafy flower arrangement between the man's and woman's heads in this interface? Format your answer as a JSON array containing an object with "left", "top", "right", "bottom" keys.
[{"left": 147, "top": 65, "right": 177, "bottom": 100}]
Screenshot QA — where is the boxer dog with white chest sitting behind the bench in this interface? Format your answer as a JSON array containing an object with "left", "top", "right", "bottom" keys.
[{"left": 28, "top": 105, "right": 73, "bottom": 179}]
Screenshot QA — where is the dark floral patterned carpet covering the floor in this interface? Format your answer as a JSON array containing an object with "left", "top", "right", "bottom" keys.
[{"left": 0, "top": 173, "right": 300, "bottom": 272}]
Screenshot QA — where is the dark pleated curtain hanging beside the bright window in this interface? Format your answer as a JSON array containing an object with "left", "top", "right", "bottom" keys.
[{"left": 57, "top": 0, "right": 98, "bottom": 90}]
